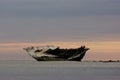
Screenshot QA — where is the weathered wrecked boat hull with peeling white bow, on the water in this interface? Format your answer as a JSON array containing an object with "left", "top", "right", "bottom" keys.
[{"left": 24, "top": 46, "right": 89, "bottom": 61}]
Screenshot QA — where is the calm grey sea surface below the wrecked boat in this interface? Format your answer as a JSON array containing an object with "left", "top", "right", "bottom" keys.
[{"left": 0, "top": 60, "right": 120, "bottom": 80}]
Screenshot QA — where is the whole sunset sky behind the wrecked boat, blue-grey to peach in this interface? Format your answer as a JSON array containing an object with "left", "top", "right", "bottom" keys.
[{"left": 0, "top": 0, "right": 120, "bottom": 60}]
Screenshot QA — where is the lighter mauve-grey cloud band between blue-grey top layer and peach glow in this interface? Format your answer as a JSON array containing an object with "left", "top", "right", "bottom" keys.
[{"left": 0, "top": 16, "right": 120, "bottom": 42}]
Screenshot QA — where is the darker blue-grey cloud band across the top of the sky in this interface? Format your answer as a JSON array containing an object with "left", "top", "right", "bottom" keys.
[{"left": 0, "top": 0, "right": 120, "bottom": 17}]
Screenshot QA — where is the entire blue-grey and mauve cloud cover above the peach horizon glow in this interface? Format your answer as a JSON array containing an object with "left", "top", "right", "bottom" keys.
[{"left": 0, "top": 0, "right": 120, "bottom": 42}]
